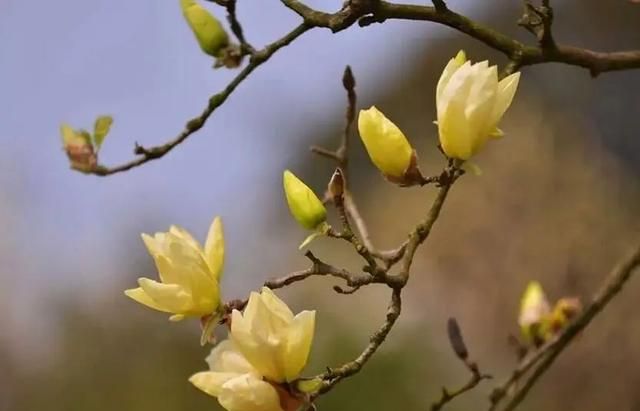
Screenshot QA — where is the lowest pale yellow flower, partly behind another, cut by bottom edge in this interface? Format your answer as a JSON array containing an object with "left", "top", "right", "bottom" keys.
[{"left": 189, "top": 340, "right": 282, "bottom": 411}]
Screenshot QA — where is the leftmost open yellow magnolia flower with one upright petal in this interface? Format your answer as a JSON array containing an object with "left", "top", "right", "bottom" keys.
[{"left": 124, "top": 217, "right": 224, "bottom": 321}]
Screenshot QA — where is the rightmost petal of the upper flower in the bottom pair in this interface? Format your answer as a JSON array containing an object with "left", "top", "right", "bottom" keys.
[{"left": 282, "top": 311, "right": 316, "bottom": 381}]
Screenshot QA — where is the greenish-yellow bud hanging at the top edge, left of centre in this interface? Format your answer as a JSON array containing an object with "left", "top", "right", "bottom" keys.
[{"left": 180, "top": 0, "right": 229, "bottom": 57}]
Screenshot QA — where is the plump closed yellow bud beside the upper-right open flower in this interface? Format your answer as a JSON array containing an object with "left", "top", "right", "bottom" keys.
[{"left": 358, "top": 106, "right": 413, "bottom": 179}]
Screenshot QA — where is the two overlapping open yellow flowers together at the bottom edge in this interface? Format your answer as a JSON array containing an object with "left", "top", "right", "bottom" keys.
[{"left": 189, "top": 287, "right": 315, "bottom": 411}]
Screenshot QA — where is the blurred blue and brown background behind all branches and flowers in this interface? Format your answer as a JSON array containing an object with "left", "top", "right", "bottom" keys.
[{"left": 0, "top": 0, "right": 640, "bottom": 411}]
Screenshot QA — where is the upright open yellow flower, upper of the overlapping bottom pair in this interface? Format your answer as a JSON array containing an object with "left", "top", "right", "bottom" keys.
[{"left": 231, "top": 287, "right": 316, "bottom": 383}]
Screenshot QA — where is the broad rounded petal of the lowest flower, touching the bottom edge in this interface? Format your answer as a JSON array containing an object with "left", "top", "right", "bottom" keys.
[{"left": 218, "top": 374, "right": 282, "bottom": 411}]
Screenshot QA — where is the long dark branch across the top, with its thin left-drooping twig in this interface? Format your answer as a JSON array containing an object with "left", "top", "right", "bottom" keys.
[{"left": 83, "top": 0, "right": 640, "bottom": 176}]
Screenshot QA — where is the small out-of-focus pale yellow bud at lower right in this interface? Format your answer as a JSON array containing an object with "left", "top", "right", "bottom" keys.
[{"left": 518, "top": 281, "right": 551, "bottom": 345}]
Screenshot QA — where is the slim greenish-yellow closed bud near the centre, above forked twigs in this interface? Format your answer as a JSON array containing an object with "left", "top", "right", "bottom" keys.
[{"left": 282, "top": 170, "right": 327, "bottom": 230}]
